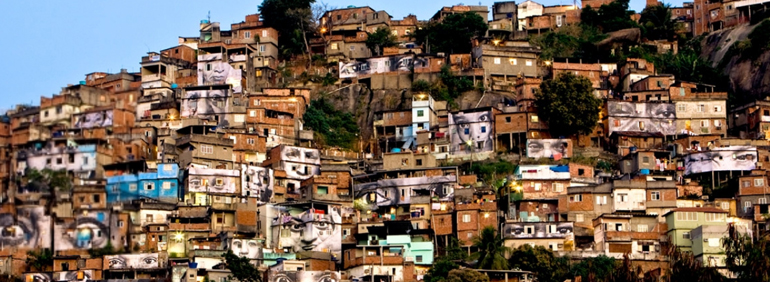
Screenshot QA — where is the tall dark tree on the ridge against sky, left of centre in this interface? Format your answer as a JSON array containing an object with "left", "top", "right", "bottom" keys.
[{"left": 259, "top": 0, "right": 315, "bottom": 57}]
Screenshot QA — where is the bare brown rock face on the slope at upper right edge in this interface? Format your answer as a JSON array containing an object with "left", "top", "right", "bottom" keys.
[{"left": 701, "top": 22, "right": 770, "bottom": 100}]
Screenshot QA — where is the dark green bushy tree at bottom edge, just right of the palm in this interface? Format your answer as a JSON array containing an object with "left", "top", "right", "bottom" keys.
[{"left": 508, "top": 244, "right": 568, "bottom": 282}]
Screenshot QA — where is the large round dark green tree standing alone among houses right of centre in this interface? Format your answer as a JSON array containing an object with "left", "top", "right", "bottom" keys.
[{"left": 535, "top": 72, "right": 602, "bottom": 137}]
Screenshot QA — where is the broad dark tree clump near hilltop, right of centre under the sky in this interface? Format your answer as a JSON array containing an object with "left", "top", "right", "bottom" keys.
[{"left": 414, "top": 12, "right": 488, "bottom": 54}]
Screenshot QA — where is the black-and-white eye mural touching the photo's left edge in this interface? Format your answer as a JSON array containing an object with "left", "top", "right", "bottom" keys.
[{"left": 0, "top": 206, "right": 51, "bottom": 249}]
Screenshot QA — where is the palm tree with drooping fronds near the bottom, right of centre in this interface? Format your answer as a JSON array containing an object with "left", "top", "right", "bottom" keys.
[{"left": 471, "top": 226, "right": 510, "bottom": 270}]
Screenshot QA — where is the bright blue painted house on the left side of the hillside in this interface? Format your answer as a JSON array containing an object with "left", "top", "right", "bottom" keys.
[{"left": 107, "top": 163, "right": 181, "bottom": 203}]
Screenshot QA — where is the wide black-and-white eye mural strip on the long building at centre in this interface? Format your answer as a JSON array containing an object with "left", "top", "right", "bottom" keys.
[{"left": 354, "top": 175, "right": 457, "bottom": 207}]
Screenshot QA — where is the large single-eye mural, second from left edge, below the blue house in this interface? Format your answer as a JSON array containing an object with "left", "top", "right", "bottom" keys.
[{"left": 54, "top": 211, "right": 110, "bottom": 251}]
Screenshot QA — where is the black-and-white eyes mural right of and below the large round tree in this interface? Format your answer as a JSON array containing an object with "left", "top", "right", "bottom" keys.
[{"left": 607, "top": 101, "right": 676, "bottom": 135}]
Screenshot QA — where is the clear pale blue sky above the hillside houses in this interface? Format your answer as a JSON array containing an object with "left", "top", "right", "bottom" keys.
[{"left": 0, "top": 0, "right": 681, "bottom": 112}]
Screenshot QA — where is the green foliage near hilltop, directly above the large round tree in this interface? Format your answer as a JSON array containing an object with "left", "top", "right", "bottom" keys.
[{"left": 529, "top": 25, "right": 605, "bottom": 61}]
